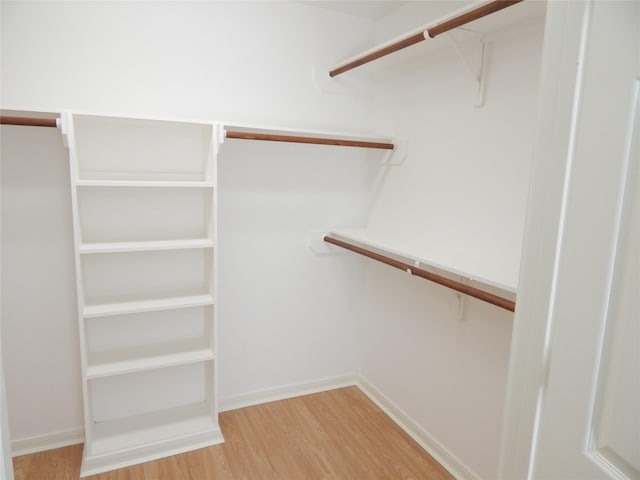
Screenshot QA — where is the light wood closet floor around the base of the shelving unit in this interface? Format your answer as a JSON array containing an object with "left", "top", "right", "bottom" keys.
[{"left": 13, "top": 387, "right": 453, "bottom": 480}]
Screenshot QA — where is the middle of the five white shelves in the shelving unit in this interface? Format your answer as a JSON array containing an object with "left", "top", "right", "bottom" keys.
[{"left": 82, "top": 294, "right": 215, "bottom": 318}]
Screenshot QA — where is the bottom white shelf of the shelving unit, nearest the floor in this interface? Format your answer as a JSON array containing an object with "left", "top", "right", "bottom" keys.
[{"left": 91, "top": 402, "right": 218, "bottom": 456}]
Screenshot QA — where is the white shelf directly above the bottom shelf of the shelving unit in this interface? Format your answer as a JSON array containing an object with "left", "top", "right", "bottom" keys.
[{"left": 87, "top": 339, "right": 215, "bottom": 379}]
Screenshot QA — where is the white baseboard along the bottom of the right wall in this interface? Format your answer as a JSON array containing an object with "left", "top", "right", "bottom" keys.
[{"left": 356, "top": 375, "right": 480, "bottom": 480}]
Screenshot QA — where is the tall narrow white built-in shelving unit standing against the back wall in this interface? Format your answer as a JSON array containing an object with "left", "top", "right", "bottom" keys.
[{"left": 62, "top": 114, "right": 223, "bottom": 476}]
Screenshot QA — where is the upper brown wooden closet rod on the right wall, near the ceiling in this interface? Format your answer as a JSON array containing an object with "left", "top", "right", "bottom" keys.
[{"left": 329, "top": 0, "right": 522, "bottom": 77}]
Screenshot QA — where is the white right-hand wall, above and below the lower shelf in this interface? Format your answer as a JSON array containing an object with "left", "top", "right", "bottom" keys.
[{"left": 360, "top": 3, "right": 543, "bottom": 478}]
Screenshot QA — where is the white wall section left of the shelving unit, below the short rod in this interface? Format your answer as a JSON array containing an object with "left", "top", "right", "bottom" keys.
[{"left": 0, "top": 126, "right": 82, "bottom": 446}]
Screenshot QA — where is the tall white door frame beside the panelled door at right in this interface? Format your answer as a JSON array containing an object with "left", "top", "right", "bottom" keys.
[{"left": 499, "top": 1, "right": 636, "bottom": 480}]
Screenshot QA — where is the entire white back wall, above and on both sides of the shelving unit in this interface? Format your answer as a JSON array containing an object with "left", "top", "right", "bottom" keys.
[{"left": 1, "top": 1, "right": 373, "bottom": 446}]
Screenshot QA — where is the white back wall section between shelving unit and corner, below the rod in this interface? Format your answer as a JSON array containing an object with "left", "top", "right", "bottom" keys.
[{"left": 218, "top": 141, "right": 370, "bottom": 397}]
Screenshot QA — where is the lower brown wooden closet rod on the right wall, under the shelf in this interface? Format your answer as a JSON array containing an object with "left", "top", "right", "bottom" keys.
[{"left": 324, "top": 236, "right": 516, "bottom": 312}]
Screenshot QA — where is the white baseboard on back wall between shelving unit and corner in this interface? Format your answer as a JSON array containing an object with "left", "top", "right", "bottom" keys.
[{"left": 218, "top": 374, "right": 358, "bottom": 412}]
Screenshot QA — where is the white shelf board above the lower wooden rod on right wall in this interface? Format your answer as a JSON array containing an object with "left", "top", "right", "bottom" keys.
[{"left": 330, "top": 228, "right": 519, "bottom": 293}]
